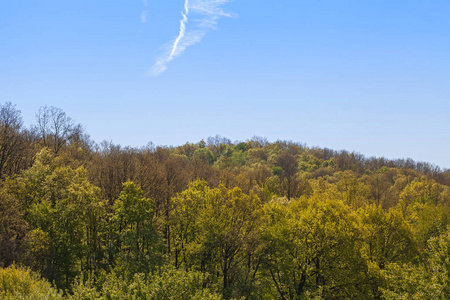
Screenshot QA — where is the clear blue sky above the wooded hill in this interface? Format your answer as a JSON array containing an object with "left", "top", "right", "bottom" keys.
[{"left": 0, "top": 0, "right": 450, "bottom": 168}]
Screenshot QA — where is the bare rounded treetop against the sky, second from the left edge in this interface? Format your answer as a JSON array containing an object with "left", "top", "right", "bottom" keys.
[{"left": 36, "top": 106, "right": 83, "bottom": 154}]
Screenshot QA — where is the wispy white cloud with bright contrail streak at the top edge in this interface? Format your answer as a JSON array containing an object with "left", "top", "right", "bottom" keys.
[{"left": 150, "top": 0, "right": 231, "bottom": 76}]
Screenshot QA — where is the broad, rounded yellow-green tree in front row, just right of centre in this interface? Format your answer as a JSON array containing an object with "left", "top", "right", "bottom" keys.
[{"left": 262, "top": 197, "right": 368, "bottom": 299}]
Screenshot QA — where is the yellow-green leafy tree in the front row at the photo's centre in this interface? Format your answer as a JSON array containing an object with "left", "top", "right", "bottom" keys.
[{"left": 171, "top": 180, "right": 261, "bottom": 299}]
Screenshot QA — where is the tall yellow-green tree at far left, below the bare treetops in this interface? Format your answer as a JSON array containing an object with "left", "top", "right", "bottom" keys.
[{"left": 8, "top": 148, "right": 106, "bottom": 288}]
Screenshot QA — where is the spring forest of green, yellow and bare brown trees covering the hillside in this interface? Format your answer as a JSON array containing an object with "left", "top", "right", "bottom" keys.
[{"left": 0, "top": 102, "right": 450, "bottom": 300}]
